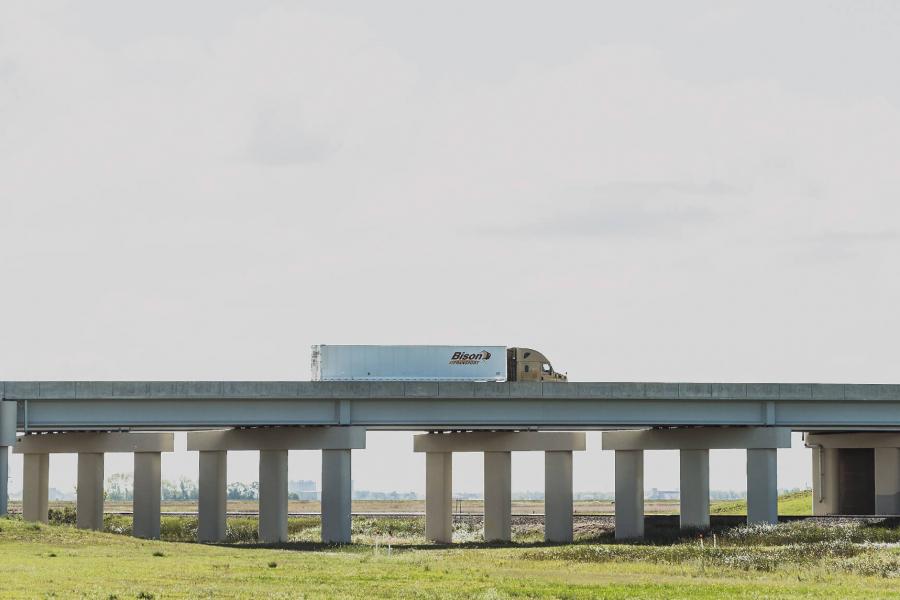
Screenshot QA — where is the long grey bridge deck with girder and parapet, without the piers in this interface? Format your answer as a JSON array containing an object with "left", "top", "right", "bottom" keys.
[{"left": 0, "top": 381, "right": 900, "bottom": 432}]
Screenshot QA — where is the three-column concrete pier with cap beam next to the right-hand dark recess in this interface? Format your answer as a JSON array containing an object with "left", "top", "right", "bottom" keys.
[{"left": 603, "top": 427, "right": 791, "bottom": 539}]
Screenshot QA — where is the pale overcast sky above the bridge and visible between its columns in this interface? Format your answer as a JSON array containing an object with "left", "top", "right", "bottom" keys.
[{"left": 0, "top": 0, "right": 900, "bottom": 491}]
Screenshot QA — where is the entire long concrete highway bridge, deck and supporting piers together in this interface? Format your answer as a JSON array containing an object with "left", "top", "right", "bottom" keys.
[{"left": 0, "top": 381, "right": 900, "bottom": 543}]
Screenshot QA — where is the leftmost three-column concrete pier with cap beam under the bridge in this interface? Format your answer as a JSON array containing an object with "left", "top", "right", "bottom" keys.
[{"left": 13, "top": 433, "right": 174, "bottom": 538}]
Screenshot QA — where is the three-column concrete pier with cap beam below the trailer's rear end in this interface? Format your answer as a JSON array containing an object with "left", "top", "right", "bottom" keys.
[{"left": 187, "top": 427, "right": 366, "bottom": 544}]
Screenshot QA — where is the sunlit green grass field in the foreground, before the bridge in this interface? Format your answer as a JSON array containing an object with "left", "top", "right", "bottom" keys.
[{"left": 0, "top": 519, "right": 900, "bottom": 600}]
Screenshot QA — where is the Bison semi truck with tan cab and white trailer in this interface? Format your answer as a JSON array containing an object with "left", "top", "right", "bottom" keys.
[{"left": 311, "top": 344, "right": 567, "bottom": 382}]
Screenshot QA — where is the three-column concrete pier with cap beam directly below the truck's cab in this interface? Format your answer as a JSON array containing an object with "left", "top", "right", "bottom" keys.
[{"left": 413, "top": 431, "right": 585, "bottom": 544}]
